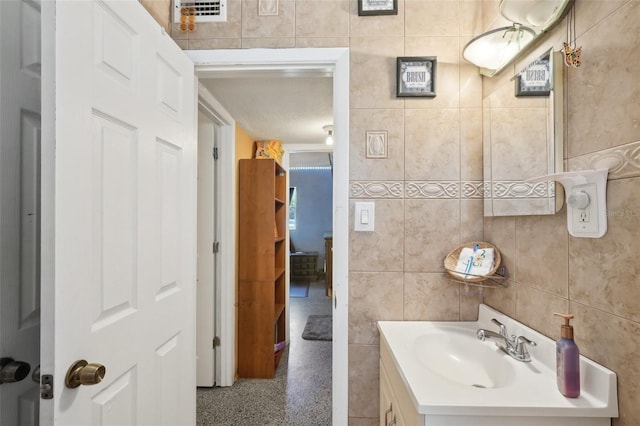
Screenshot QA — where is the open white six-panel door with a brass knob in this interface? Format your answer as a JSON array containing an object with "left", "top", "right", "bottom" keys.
[{"left": 42, "top": 0, "right": 197, "bottom": 426}]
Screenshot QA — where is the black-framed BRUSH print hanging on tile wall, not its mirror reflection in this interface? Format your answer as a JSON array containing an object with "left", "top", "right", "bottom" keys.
[{"left": 396, "top": 56, "right": 437, "bottom": 98}]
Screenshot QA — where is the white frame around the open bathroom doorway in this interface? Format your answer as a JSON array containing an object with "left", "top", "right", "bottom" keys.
[{"left": 186, "top": 48, "right": 349, "bottom": 424}]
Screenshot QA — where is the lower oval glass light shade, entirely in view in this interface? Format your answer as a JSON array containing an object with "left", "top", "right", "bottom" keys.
[{"left": 462, "top": 24, "right": 535, "bottom": 74}]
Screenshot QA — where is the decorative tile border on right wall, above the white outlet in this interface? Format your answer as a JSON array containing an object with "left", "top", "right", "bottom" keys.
[{"left": 569, "top": 141, "right": 640, "bottom": 180}]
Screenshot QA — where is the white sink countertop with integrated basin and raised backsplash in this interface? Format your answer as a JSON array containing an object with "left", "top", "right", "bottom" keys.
[{"left": 378, "top": 305, "right": 618, "bottom": 426}]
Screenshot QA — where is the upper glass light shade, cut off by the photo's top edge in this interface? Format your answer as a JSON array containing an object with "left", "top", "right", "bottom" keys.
[{"left": 499, "top": 0, "right": 569, "bottom": 31}]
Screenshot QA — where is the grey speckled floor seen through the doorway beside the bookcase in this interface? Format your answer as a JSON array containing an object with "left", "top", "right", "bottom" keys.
[{"left": 197, "top": 281, "right": 332, "bottom": 426}]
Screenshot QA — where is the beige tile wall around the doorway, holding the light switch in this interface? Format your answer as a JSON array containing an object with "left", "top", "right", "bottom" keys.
[{"left": 168, "top": 0, "right": 483, "bottom": 424}]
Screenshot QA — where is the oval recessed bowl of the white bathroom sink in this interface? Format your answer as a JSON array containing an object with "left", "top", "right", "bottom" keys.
[{"left": 413, "top": 326, "right": 515, "bottom": 389}]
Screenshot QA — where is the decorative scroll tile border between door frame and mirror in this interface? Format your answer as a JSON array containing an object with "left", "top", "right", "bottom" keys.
[{"left": 350, "top": 181, "right": 485, "bottom": 199}]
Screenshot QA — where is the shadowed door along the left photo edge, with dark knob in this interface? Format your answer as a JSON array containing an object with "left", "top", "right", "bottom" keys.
[{"left": 0, "top": 0, "right": 41, "bottom": 426}]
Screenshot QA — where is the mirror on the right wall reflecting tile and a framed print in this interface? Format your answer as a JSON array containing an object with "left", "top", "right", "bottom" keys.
[{"left": 482, "top": 50, "right": 564, "bottom": 216}]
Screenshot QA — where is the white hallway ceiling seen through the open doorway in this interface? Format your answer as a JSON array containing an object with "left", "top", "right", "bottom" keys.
[{"left": 200, "top": 72, "right": 333, "bottom": 145}]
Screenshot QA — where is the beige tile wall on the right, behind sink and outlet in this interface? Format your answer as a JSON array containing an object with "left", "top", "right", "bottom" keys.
[{"left": 484, "top": 1, "right": 640, "bottom": 426}]
